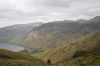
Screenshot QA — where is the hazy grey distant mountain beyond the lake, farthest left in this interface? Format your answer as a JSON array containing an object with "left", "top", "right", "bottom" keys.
[{"left": 0, "top": 22, "right": 42, "bottom": 41}]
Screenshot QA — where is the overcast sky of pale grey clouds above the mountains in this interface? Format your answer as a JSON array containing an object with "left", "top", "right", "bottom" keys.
[{"left": 0, "top": 0, "right": 100, "bottom": 27}]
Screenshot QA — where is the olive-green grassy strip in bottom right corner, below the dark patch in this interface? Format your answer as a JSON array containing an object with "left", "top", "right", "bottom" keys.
[{"left": 54, "top": 56, "right": 100, "bottom": 66}]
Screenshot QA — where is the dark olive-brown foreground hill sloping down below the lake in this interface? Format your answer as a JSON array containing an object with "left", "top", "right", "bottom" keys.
[{"left": 0, "top": 49, "right": 46, "bottom": 66}]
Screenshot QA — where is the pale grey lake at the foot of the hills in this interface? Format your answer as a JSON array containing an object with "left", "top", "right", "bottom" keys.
[{"left": 0, "top": 43, "right": 24, "bottom": 52}]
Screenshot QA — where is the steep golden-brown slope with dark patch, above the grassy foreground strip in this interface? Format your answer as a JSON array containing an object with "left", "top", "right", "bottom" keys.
[{"left": 42, "top": 31, "right": 100, "bottom": 63}]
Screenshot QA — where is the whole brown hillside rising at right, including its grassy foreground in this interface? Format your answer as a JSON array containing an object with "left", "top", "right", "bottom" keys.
[{"left": 42, "top": 31, "right": 100, "bottom": 66}]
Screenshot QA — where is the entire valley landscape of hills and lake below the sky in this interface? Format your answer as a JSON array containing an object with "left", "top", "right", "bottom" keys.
[{"left": 0, "top": 16, "right": 100, "bottom": 66}]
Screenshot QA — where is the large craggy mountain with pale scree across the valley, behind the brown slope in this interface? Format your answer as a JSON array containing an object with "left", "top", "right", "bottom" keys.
[{"left": 12, "top": 16, "right": 100, "bottom": 49}]
